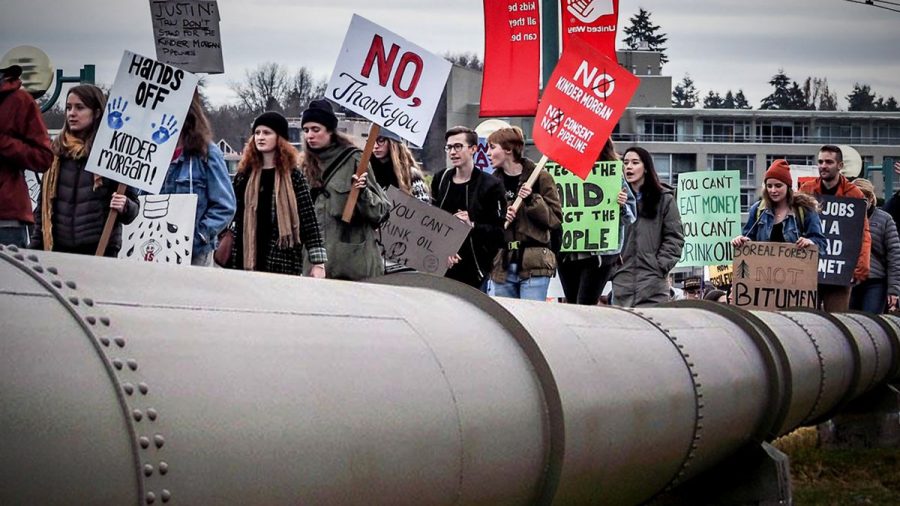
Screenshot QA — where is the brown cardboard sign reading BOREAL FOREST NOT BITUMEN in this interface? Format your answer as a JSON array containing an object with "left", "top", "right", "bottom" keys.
[{"left": 732, "top": 242, "right": 819, "bottom": 311}]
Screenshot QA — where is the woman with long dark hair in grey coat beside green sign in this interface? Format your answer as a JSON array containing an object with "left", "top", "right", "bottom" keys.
[{"left": 613, "top": 147, "right": 684, "bottom": 307}]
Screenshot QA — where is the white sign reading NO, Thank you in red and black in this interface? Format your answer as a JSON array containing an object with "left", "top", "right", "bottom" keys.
[{"left": 325, "top": 14, "right": 452, "bottom": 146}]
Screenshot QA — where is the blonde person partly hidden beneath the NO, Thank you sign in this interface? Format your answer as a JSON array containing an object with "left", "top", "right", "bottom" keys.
[{"left": 371, "top": 128, "right": 431, "bottom": 203}]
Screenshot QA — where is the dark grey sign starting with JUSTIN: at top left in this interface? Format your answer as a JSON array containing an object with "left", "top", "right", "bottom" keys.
[{"left": 150, "top": 0, "right": 225, "bottom": 74}]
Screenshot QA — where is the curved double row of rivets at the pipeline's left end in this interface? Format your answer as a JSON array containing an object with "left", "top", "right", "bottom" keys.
[{"left": 0, "top": 255, "right": 172, "bottom": 504}]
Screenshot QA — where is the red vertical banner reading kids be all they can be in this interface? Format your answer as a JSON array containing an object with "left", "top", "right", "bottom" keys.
[{"left": 480, "top": 0, "right": 541, "bottom": 117}]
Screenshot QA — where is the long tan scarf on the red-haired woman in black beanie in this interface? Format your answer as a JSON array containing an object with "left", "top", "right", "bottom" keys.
[{"left": 243, "top": 168, "right": 300, "bottom": 271}]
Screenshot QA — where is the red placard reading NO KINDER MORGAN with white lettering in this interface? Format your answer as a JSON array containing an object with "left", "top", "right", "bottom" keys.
[{"left": 531, "top": 40, "right": 639, "bottom": 179}]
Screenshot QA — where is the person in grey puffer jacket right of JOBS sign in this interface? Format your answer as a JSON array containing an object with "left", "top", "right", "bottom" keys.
[{"left": 850, "top": 179, "right": 900, "bottom": 313}]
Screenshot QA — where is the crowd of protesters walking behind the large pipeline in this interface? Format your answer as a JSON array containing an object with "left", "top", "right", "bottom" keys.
[{"left": 0, "top": 61, "right": 900, "bottom": 312}]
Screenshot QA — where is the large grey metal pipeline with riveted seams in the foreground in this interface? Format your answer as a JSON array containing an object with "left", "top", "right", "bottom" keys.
[{"left": 0, "top": 248, "right": 900, "bottom": 505}]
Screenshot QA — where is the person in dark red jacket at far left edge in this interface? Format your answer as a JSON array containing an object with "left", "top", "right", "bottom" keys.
[{"left": 0, "top": 65, "right": 53, "bottom": 248}]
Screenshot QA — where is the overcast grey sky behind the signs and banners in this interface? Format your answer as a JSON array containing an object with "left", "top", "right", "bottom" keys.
[{"left": 0, "top": 0, "right": 900, "bottom": 108}]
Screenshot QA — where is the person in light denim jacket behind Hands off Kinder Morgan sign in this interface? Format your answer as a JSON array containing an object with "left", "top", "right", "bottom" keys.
[{"left": 159, "top": 91, "right": 236, "bottom": 267}]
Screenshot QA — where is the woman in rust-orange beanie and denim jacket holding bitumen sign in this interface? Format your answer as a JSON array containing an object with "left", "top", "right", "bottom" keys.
[{"left": 731, "top": 160, "right": 825, "bottom": 255}]
